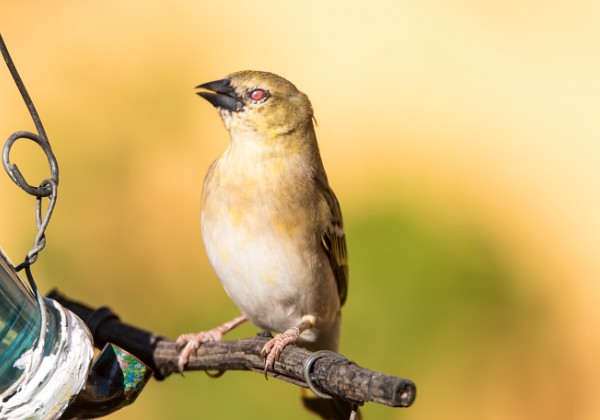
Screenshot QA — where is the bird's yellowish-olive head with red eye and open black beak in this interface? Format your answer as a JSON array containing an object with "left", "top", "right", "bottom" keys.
[{"left": 196, "top": 70, "right": 313, "bottom": 136}]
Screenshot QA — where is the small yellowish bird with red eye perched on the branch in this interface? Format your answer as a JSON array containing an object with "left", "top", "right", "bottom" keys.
[{"left": 177, "top": 71, "right": 350, "bottom": 418}]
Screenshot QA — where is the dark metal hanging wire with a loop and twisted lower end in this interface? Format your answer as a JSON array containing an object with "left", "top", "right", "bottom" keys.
[{"left": 0, "top": 35, "right": 58, "bottom": 291}]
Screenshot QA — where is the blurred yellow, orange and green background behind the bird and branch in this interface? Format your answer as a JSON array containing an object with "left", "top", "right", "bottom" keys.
[{"left": 0, "top": 0, "right": 600, "bottom": 420}]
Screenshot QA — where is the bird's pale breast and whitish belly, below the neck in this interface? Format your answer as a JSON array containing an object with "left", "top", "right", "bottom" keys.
[{"left": 201, "top": 156, "right": 339, "bottom": 331}]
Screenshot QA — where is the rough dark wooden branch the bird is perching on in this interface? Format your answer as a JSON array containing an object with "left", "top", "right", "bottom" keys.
[{"left": 48, "top": 290, "right": 416, "bottom": 407}]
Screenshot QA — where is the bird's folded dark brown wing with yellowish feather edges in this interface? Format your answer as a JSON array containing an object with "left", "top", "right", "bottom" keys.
[{"left": 319, "top": 180, "right": 348, "bottom": 305}]
